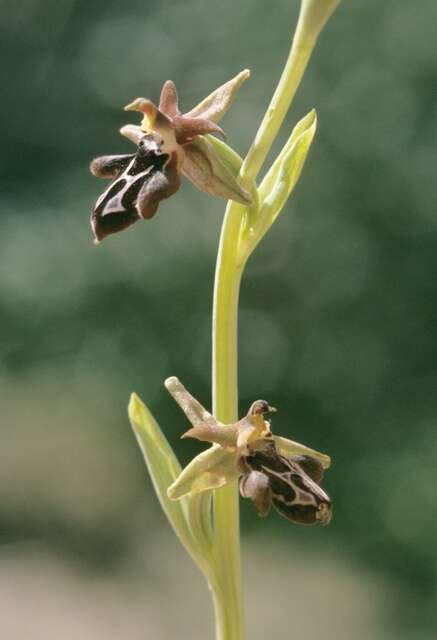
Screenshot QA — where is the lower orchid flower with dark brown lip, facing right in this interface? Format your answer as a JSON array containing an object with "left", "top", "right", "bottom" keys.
[{"left": 166, "top": 378, "right": 331, "bottom": 525}]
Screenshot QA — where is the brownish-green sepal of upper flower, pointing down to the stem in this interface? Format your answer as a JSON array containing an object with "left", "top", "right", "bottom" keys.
[{"left": 182, "top": 138, "right": 252, "bottom": 204}]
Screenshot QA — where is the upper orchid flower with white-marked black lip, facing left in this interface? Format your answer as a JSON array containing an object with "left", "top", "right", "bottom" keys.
[{"left": 90, "top": 70, "right": 251, "bottom": 243}]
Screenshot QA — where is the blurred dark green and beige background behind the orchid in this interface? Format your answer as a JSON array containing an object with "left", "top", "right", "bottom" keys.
[{"left": 0, "top": 0, "right": 437, "bottom": 640}]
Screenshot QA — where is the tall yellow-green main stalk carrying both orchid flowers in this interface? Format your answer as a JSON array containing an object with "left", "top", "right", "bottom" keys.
[{"left": 210, "top": 0, "right": 340, "bottom": 640}]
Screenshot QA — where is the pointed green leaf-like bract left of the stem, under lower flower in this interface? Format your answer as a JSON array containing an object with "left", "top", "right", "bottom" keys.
[{"left": 128, "top": 393, "right": 212, "bottom": 571}]
